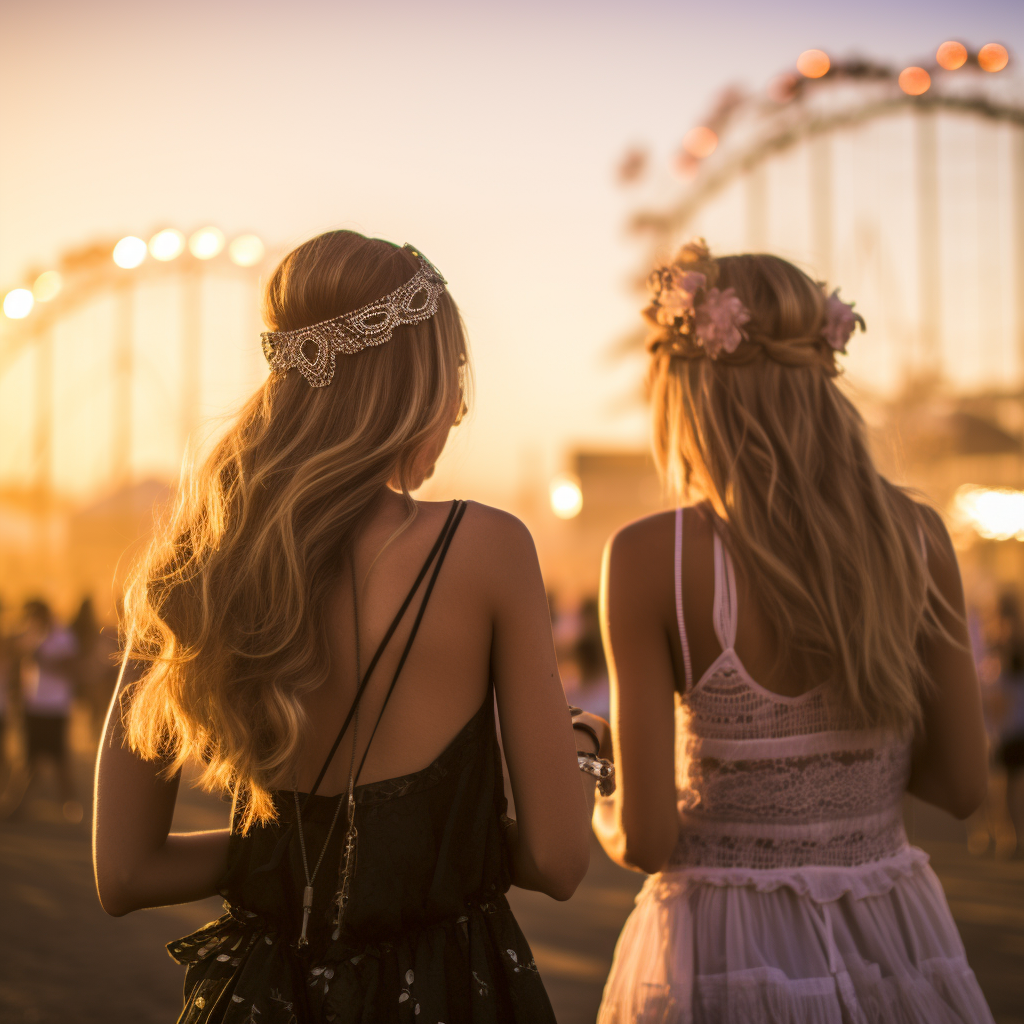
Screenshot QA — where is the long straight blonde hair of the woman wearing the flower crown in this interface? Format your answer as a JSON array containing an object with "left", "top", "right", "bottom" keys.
[{"left": 647, "top": 255, "right": 944, "bottom": 730}]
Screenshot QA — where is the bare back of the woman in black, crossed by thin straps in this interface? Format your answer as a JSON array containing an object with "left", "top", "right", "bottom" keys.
[{"left": 298, "top": 495, "right": 496, "bottom": 796}]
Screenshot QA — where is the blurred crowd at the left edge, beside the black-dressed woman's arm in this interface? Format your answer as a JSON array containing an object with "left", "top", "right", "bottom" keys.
[{"left": 0, "top": 598, "right": 118, "bottom": 822}]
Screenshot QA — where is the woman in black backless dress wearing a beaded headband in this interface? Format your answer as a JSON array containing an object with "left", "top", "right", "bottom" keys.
[{"left": 94, "top": 231, "right": 609, "bottom": 1024}]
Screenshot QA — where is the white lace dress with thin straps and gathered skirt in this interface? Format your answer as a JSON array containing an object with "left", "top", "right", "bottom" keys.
[{"left": 598, "top": 512, "right": 992, "bottom": 1024}]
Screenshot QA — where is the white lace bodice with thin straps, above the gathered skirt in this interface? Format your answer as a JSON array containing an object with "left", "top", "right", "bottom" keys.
[{"left": 671, "top": 510, "right": 909, "bottom": 870}]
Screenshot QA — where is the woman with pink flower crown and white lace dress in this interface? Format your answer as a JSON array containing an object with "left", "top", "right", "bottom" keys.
[{"left": 593, "top": 243, "right": 992, "bottom": 1024}]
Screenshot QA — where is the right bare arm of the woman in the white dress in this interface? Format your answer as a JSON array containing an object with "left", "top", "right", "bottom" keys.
[{"left": 907, "top": 516, "right": 988, "bottom": 818}]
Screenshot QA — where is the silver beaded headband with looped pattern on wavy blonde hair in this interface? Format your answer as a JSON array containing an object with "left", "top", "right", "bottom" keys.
[{"left": 260, "top": 245, "right": 447, "bottom": 387}]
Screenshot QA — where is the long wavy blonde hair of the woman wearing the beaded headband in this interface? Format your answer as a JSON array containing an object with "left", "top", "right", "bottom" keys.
[{"left": 122, "top": 231, "right": 468, "bottom": 829}]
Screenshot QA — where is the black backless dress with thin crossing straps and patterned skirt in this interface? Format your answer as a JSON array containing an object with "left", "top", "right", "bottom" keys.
[{"left": 168, "top": 503, "right": 555, "bottom": 1024}]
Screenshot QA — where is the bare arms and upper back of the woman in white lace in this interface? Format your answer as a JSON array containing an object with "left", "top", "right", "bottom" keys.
[{"left": 598, "top": 506, "right": 985, "bottom": 871}]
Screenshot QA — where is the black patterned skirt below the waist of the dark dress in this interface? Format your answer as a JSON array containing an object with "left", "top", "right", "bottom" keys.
[{"left": 167, "top": 896, "right": 555, "bottom": 1024}]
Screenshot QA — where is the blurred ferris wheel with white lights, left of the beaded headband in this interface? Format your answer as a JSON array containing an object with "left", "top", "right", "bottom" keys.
[{"left": 0, "top": 225, "right": 268, "bottom": 501}]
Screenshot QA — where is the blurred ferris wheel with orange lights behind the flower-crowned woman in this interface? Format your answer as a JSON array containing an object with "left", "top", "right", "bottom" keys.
[{"left": 620, "top": 41, "right": 1024, "bottom": 395}]
